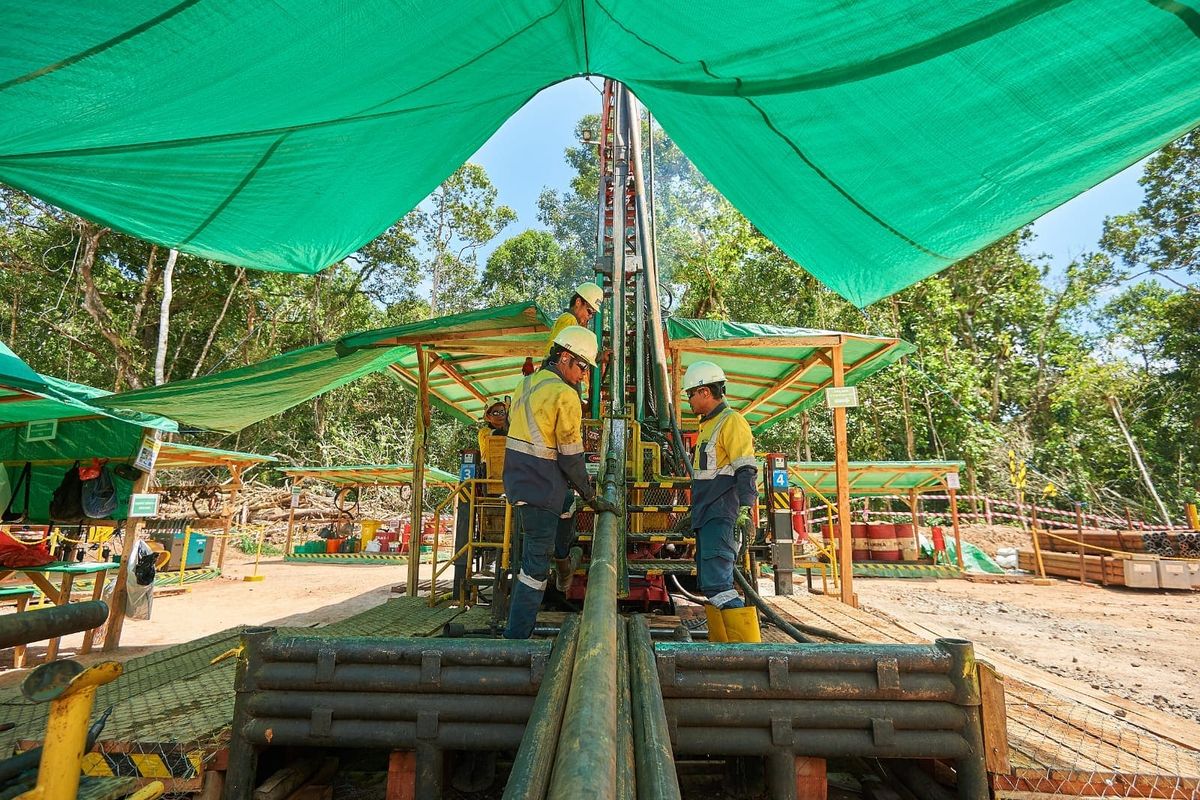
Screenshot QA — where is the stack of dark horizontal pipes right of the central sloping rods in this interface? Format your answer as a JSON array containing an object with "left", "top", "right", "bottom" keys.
[{"left": 655, "top": 639, "right": 982, "bottom": 763}]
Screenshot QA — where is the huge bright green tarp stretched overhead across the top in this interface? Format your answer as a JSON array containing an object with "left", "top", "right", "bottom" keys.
[{"left": 0, "top": 0, "right": 1200, "bottom": 305}]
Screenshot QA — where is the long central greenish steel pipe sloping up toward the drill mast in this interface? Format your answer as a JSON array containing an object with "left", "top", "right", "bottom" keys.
[{"left": 547, "top": 431, "right": 625, "bottom": 800}]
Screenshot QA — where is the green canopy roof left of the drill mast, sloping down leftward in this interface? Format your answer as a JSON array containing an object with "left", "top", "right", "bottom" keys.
[{"left": 98, "top": 302, "right": 550, "bottom": 433}]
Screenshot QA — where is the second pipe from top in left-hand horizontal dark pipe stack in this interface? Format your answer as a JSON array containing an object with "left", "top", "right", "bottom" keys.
[{"left": 256, "top": 662, "right": 539, "bottom": 696}]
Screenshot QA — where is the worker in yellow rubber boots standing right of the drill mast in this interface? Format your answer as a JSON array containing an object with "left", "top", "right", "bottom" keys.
[{"left": 683, "top": 361, "right": 760, "bottom": 642}]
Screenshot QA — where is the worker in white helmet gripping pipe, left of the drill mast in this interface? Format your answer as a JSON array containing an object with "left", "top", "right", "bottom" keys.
[{"left": 504, "top": 325, "right": 616, "bottom": 639}]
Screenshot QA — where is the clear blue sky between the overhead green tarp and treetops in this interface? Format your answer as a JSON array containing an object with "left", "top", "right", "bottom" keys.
[{"left": 470, "top": 78, "right": 1141, "bottom": 280}]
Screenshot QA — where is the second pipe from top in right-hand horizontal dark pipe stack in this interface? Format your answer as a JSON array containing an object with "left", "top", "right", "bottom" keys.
[{"left": 662, "top": 671, "right": 955, "bottom": 700}]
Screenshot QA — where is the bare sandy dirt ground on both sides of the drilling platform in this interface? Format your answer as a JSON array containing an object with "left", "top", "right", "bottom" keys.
[{"left": 0, "top": 542, "right": 1200, "bottom": 722}]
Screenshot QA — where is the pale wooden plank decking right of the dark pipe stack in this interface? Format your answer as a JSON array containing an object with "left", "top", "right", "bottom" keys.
[{"left": 767, "top": 594, "right": 1200, "bottom": 800}]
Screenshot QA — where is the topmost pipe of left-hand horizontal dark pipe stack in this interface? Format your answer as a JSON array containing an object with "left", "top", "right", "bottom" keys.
[{"left": 260, "top": 636, "right": 550, "bottom": 667}]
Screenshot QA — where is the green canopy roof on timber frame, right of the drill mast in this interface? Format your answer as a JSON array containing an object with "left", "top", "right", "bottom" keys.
[{"left": 667, "top": 317, "right": 916, "bottom": 433}]
